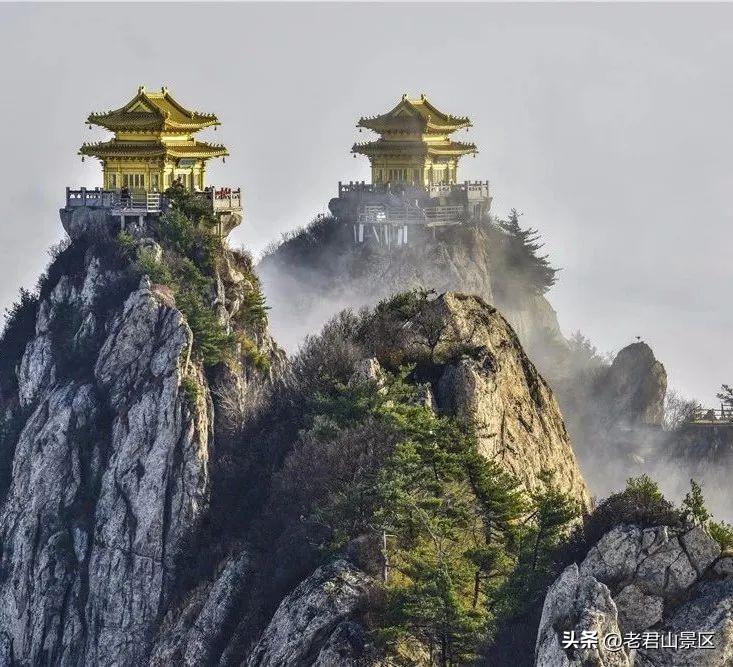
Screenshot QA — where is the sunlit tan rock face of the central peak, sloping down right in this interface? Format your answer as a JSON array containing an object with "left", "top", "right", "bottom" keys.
[{"left": 418, "top": 293, "right": 590, "bottom": 505}]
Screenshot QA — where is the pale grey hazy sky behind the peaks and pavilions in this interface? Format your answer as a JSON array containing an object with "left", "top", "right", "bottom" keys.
[{"left": 0, "top": 3, "right": 733, "bottom": 400}]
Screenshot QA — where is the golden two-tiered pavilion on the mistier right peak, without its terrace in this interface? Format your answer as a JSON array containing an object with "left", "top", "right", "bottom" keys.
[{"left": 352, "top": 95, "right": 478, "bottom": 187}]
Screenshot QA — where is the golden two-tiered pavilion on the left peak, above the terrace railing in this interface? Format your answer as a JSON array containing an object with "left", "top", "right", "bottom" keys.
[{"left": 79, "top": 86, "right": 229, "bottom": 192}]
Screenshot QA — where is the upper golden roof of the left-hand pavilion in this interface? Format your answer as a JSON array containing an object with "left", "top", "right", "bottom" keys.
[{"left": 87, "top": 86, "right": 220, "bottom": 132}]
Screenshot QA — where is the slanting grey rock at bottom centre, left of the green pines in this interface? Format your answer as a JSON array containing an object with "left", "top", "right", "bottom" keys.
[{"left": 247, "top": 560, "right": 372, "bottom": 667}]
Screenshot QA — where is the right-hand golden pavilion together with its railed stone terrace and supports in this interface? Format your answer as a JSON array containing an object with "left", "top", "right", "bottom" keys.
[{"left": 328, "top": 90, "right": 491, "bottom": 247}]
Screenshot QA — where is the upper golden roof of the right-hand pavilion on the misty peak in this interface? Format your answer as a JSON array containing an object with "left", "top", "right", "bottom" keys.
[{"left": 357, "top": 95, "right": 471, "bottom": 134}]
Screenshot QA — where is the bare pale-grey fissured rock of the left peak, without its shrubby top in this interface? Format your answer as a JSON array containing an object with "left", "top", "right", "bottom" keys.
[{"left": 0, "top": 274, "right": 210, "bottom": 664}]
